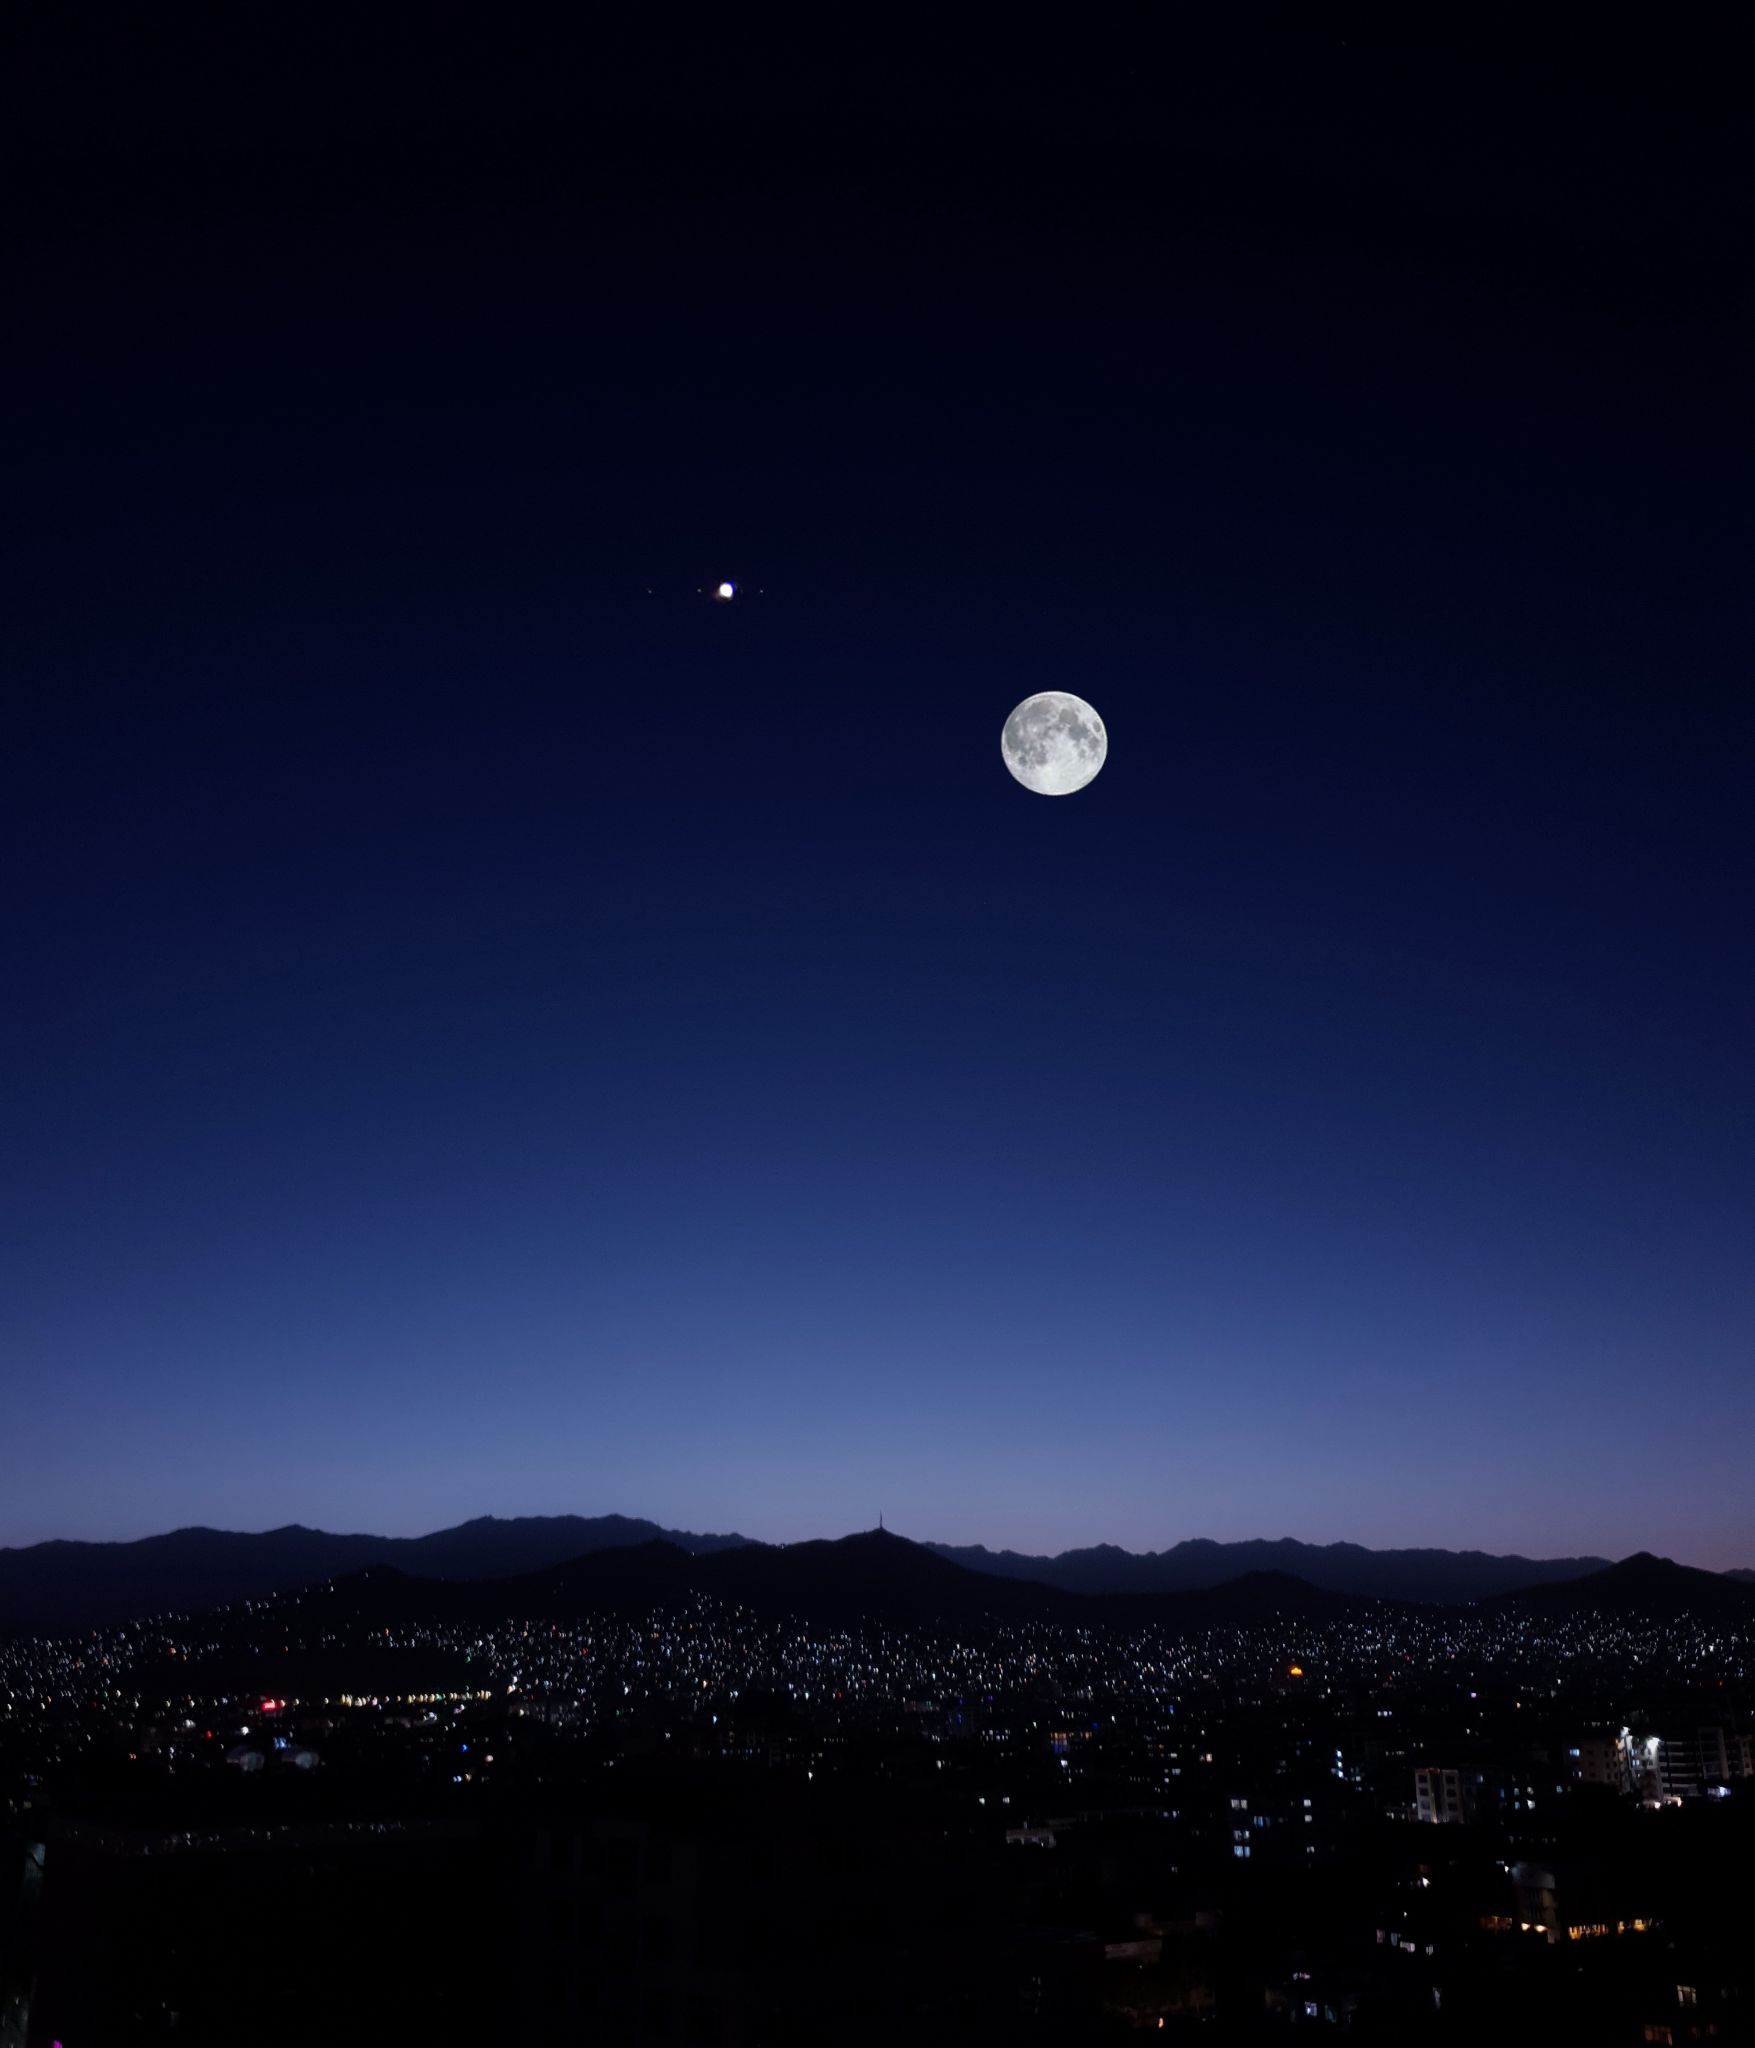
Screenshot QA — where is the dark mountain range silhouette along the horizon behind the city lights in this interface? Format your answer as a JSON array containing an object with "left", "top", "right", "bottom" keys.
[{"left": 0, "top": 1516, "right": 1755, "bottom": 1634}]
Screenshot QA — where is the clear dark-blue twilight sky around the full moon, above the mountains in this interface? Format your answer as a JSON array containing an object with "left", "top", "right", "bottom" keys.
[{"left": 0, "top": 14, "right": 1755, "bottom": 1567}]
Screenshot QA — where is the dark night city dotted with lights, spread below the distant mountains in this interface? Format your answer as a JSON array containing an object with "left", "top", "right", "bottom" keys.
[{"left": 0, "top": 1532, "right": 1755, "bottom": 2042}]
